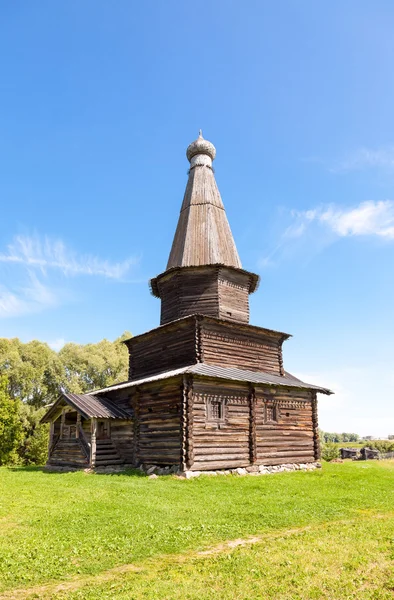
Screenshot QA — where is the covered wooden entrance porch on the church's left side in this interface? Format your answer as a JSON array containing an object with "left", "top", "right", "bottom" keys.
[{"left": 41, "top": 393, "right": 132, "bottom": 469}]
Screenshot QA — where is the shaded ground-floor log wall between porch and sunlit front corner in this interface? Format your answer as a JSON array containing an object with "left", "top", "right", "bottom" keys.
[{"left": 133, "top": 378, "right": 183, "bottom": 465}]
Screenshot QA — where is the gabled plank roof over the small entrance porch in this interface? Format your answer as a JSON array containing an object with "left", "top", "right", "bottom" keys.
[{"left": 41, "top": 392, "right": 132, "bottom": 423}]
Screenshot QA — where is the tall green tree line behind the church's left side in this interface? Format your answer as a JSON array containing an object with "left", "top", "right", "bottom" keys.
[{"left": 0, "top": 331, "right": 131, "bottom": 465}]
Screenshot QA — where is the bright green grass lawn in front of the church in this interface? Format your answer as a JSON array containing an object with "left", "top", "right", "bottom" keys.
[{"left": 0, "top": 461, "right": 394, "bottom": 600}]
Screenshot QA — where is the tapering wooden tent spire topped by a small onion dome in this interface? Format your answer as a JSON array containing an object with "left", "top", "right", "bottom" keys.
[{"left": 167, "top": 130, "right": 241, "bottom": 270}]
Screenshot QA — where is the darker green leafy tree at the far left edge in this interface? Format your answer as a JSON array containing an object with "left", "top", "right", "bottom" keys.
[{"left": 0, "top": 375, "right": 24, "bottom": 465}]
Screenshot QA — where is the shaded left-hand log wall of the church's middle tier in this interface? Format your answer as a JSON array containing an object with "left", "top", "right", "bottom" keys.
[{"left": 127, "top": 317, "right": 196, "bottom": 379}]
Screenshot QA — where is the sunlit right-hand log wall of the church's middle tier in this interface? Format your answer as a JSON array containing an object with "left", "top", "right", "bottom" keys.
[{"left": 200, "top": 318, "right": 284, "bottom": 375}]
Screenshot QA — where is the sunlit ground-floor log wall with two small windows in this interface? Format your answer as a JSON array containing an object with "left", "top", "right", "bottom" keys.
[{"left": 188, "top": 379, "right": 317, "bottom": 471}]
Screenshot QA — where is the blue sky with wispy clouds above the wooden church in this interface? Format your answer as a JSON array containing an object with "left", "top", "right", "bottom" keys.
[{"left": 0, "top": 0, "right": 394, "bottom": 435}]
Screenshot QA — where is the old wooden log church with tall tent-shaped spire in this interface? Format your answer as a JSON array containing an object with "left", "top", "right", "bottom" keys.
[{"left": 43, "top": 133, "right": 330, "bottom": 471}]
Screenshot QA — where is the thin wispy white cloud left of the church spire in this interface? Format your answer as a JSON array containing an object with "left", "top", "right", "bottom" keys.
[{"left": 0, "top": 235, "right": 138, "bottom": 279}]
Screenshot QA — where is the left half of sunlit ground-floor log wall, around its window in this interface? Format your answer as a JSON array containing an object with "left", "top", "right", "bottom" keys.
[{"left": 190, "top": 380, "right": 250, "bottom": 471}]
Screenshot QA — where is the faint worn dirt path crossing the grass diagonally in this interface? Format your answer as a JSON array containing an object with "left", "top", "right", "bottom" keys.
[{"left": 0, "top": 510, "right": 394, "bottom": 600}]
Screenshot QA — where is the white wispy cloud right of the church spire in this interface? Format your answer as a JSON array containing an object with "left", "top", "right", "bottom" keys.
[{"left": 259, "top": 200, "right": 394, "bottom": 268}]
